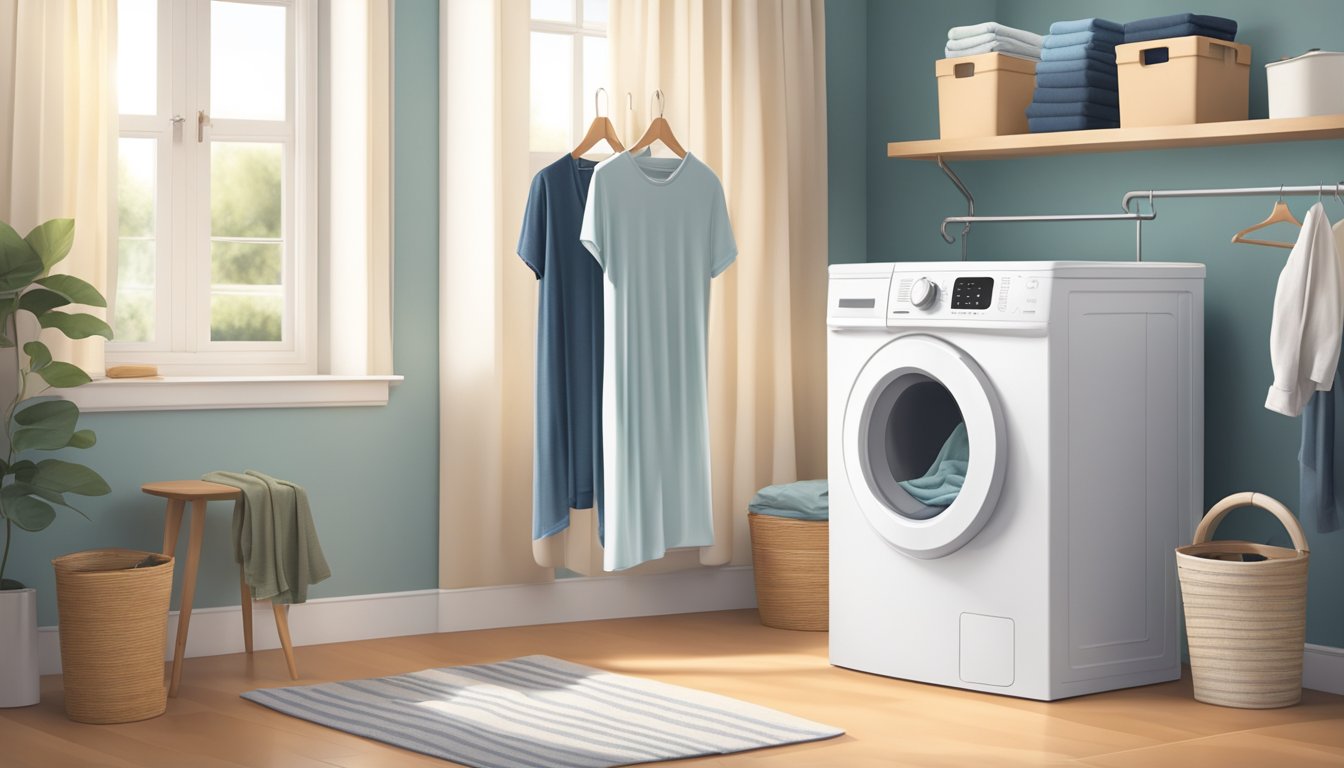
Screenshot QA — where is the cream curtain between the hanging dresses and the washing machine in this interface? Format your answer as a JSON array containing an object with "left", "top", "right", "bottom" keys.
[{"left": 609, "top": 0, "right": 827, "bottom": 565}]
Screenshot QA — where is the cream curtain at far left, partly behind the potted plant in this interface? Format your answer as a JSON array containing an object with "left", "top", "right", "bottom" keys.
[{"left": 0, "top": 0, "right": 117, "bottom": 377}]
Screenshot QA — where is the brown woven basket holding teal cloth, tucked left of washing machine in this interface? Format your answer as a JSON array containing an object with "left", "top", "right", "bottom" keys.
[{"left": 747, "top": 512, "right": 831, "bottom": 632}]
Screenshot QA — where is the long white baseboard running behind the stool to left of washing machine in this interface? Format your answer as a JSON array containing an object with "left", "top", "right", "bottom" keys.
[{"left": 38, "top": 566, "right": 755, "bottom": 675}]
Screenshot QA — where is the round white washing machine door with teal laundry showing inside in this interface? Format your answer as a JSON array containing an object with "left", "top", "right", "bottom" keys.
[{"left": 844, "top": 335, "right": 1008, "bottom": 558}]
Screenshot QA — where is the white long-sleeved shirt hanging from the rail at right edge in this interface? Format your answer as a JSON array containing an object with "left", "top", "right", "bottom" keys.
[{"left": 1265, "top": 203, "right": 1344, "bottom": 416}]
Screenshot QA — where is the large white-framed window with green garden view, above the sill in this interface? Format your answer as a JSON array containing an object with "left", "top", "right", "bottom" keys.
[{"left": 108, "top": 0, "right": 319, "bottom": 374}]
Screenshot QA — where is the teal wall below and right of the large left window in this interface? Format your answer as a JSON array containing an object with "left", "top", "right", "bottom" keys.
[{"left": 8, "top": 0, "right": 438, "bottom": 625}]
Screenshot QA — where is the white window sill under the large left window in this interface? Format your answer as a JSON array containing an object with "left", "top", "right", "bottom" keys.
[{"left": 56, "top": 375, "right": 403, "bottom": 413}]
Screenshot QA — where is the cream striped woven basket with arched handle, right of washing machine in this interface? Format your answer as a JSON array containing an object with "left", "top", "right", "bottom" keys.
[{"left": 1176, "top": 492, "right": 1308, "bottom": 709}]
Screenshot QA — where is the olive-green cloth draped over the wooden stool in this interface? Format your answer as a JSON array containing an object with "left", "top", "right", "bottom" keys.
[{"left": 202, "top": 469, "right": 332, "bottom": 604}]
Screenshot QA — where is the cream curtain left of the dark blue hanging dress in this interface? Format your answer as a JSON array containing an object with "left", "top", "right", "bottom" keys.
[{"left": 439, "top": 0, "right": 554, "bottom": 588}]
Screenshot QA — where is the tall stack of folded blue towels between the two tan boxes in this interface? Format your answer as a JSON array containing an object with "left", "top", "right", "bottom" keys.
[{"left": 1027, "top": 19, "right": 1125, "bottom": 133}]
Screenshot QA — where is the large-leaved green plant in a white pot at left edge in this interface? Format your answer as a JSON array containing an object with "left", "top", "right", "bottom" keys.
[{"left": 0, "top": 219, "right": 112, "bottom": 707}]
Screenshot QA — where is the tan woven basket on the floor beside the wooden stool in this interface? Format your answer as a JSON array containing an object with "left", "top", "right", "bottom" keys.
[{"left": 51, "top": 549, "right": 173, "bottom": 724}]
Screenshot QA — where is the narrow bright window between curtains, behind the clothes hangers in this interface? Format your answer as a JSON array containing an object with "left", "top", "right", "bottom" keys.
[{"left": 528, "top": 0, "right": 617, "bottom": 169}]
